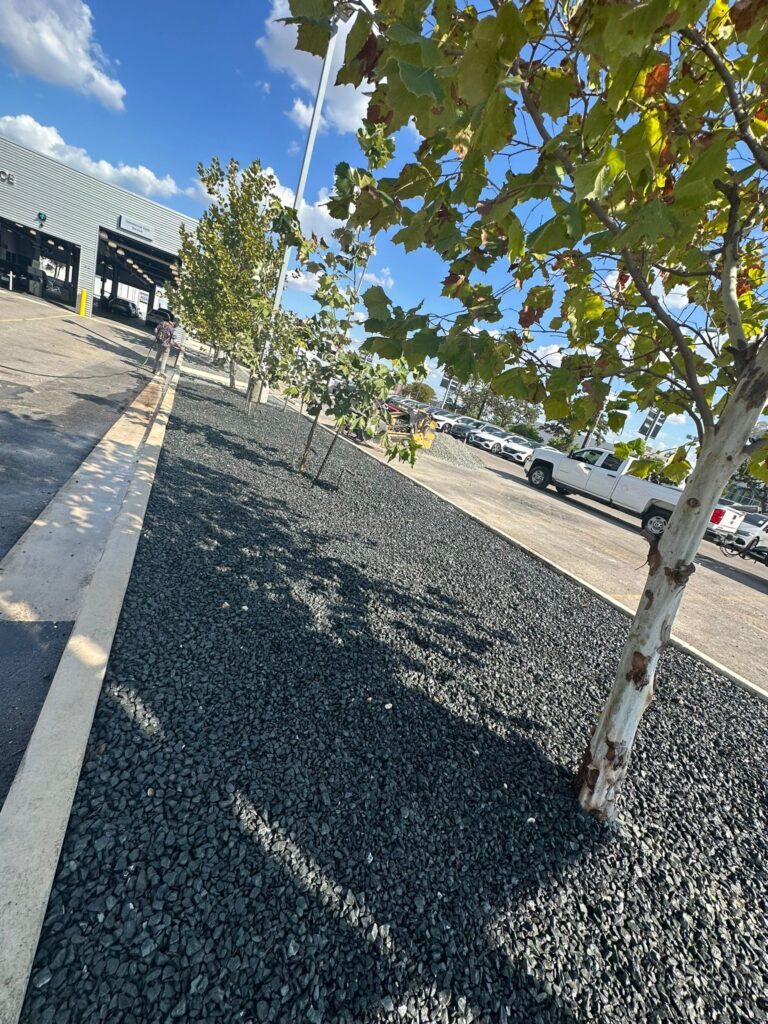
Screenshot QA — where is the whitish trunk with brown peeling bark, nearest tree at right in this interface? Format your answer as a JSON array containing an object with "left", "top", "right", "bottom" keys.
[{"left": 577, "top": 345, "right": 768, "bottom": 819}]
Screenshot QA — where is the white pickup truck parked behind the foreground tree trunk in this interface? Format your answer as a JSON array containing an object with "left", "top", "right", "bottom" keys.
[{"left": 523, "top": 447, "right": 743, "bottom": 536}]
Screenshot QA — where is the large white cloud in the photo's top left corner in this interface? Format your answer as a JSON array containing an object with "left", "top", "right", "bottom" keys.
[{"left": 0, "top": 0, "right": 125, "bottom": 111}]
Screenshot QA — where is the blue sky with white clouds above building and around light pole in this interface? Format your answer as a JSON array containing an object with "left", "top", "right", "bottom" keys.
[{"left": 0, "top": 0, "right": 692, "bottom": 444}]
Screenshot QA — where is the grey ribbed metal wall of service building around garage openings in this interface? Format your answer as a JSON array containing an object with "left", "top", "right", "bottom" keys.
[{"left": 0, "top": 138, "right": 197, "bottom": 313}]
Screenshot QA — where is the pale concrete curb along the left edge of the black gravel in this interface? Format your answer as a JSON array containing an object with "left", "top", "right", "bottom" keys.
[{"left": 0, "top": 373, "right": 178, "bottom": 1024}]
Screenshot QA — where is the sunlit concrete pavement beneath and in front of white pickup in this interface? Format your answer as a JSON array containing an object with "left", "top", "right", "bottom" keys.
[{"left": 374, "top": 430, "right": 768, "bottom": 690}]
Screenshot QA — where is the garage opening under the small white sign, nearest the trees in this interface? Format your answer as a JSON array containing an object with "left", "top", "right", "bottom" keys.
[{"left": 93, "top": 227, "right": 177, "bottom": 330}]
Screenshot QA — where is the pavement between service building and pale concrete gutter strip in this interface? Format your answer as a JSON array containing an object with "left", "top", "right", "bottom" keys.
[{"left": 0, "top": 291, "right": 152, "bottom": 558}]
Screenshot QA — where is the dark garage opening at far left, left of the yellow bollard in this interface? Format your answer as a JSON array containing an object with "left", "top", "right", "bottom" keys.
[{"left": 0, "top": 217, "right": 80, "bottom": 306}]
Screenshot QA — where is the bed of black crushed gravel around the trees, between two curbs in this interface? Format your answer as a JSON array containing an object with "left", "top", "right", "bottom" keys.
[{"left": 22, "top": 382, "right": 768, "bottom": 1024}]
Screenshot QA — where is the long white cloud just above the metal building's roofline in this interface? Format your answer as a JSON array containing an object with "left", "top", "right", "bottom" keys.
[{"left": 0, "top": 114, "right": 202, "bottom": 200}]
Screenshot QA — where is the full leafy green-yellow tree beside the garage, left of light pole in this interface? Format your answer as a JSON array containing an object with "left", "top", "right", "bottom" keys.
[{"left": 168, "top": 157, "right": 291, "bottom": 387}]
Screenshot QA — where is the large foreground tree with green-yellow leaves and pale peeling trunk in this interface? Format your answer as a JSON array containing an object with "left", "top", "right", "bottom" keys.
[{"left": 292, "top": 0, "right": 768, "bottom": 818}]
